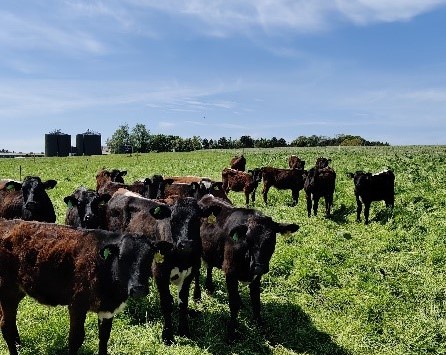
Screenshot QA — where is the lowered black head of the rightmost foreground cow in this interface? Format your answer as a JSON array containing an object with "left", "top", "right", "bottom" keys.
[{"left": 229, "top": 215, "right": 299, "bottom": 281}]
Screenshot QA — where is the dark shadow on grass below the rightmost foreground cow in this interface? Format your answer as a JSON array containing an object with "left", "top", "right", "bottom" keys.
[{"left": 193, "top": 300, "right": 349, "bottom": 355}]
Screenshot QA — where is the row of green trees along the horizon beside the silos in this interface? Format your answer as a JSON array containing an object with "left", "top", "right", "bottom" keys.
[{"left": 106, "top": 123, "right": 390, "bottom": 153}]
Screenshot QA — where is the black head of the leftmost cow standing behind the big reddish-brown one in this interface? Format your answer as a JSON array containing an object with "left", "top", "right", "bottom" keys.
[{"left": 22, "top": 176, "right": 57, "bottom": 223}]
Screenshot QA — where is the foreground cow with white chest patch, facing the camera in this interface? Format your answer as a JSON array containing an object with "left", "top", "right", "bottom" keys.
[{"left": 108, "top": 190, "right": 219, "bottom": 345}]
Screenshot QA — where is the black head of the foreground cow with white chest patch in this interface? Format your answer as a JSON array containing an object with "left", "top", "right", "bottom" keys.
[{"left": 150, "top": 197, "right": 221, "bottom": 253}]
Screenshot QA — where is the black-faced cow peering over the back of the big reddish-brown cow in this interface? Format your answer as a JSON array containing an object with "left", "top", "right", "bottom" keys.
[{"left": 64, "top": 186, "right": 111, "bottom": 229}]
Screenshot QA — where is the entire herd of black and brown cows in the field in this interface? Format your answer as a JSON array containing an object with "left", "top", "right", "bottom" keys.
[{"left": 0, "top": 155, "right": 395, "bottom": 354}]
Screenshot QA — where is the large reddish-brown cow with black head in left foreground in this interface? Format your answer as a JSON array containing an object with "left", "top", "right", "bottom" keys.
[{"left": 0, "top": 219, "right": 167, "bottom": 355}]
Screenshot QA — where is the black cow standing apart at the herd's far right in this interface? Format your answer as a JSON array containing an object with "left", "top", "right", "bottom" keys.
[{"left": 347, "top": 169, "right": 395, "bottom": 224}]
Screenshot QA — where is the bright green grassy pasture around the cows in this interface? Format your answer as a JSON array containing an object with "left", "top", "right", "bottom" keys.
[{"left": 0, "top": 146, "right": 446, "bottom": 355}]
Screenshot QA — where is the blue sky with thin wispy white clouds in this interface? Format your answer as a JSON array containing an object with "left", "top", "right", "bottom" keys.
[{"left": 0, "top": 0, "right": 446, "bottom": 152}]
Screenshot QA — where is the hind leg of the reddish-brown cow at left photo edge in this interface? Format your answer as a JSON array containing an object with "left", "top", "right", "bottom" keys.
[{"left": 0, "top": 293, "right": 23, "bottom": 355}]
